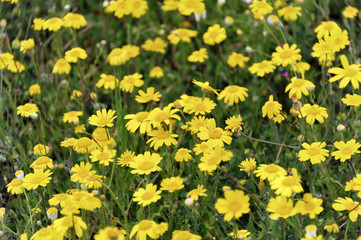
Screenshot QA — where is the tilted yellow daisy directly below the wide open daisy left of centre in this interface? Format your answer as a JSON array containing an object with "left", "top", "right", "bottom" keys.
[{"left": 133, "top": 183, "right": 162, "bottom": 207}]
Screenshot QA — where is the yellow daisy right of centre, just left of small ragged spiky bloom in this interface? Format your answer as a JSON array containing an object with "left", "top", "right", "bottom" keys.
[{"left": 197, "top": 118, "right": 232, "bottom": 147}]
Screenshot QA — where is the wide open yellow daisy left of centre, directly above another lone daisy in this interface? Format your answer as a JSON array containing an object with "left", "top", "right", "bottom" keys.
[{"left": 129, "top": 151, "right": 162, "bottom": 175}]
